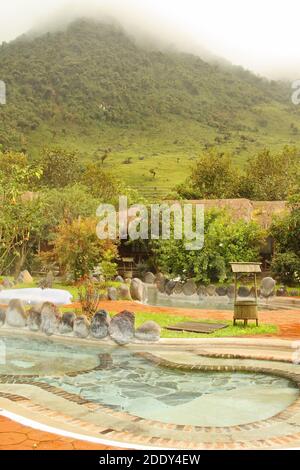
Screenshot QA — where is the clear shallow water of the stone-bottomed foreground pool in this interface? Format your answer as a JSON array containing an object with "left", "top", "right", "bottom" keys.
[{"left": 0, "top": 337, "right": 299, "bottom": 426}]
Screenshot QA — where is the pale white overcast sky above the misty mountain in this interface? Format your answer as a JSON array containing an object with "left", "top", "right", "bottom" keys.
[{"left": 0, "top": 0, "right": 300, "bottom": 79}]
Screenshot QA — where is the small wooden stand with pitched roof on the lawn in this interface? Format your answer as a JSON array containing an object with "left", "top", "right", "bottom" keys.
[{"left": 230, "top": 262, "right": 261, "bottom": 326}]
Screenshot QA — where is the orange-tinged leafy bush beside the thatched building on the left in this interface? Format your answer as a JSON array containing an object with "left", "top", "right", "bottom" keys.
[{"left": 49, "top": 218, "right": 117, "bottom": 281}]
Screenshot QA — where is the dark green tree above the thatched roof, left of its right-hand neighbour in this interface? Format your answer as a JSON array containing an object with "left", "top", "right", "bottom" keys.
[{"left": 177, "top": 150, "right": 240, "bottom": 199}]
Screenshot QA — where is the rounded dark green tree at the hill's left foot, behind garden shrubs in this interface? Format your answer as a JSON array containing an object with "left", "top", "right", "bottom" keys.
[{"left": 40, "top": 148, "right": 81, "bottom": 188}]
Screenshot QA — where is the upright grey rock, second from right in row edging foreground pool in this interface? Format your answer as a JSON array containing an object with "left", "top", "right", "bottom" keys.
[{"left": 108, "top": 310, "right": 135, "bottom": 345}]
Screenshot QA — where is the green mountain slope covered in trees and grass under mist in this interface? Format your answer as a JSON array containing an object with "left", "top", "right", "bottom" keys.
[{"left": 0, "top": 20, "right": 300, "bottom": 194}]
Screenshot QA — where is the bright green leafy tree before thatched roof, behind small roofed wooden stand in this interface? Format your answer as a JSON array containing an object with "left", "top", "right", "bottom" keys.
[{"left": 152, "top": 210, "right": 264, "bottom": 284}]
